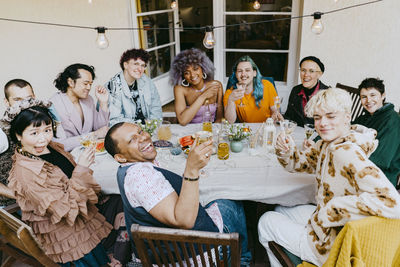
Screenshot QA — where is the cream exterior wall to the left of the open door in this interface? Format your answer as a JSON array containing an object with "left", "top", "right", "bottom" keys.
[{"left": 0, "top": 0, "right": 134, "bottom": 114}]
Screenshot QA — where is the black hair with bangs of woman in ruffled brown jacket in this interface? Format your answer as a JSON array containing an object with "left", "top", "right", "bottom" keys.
[{"left": 10, "top": 106, "right": 55, "bottom": 143}]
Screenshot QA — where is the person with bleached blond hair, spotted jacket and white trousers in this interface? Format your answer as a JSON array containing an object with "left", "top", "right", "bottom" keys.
[{"left": 258, "top": 88, "right": 400, "bottom": 266}]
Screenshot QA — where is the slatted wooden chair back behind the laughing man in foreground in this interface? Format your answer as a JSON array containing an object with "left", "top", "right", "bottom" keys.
[{"left": 131, "top": 224, "right": 240, "bottom": 267}]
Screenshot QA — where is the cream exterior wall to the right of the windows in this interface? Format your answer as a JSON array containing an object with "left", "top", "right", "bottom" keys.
[{"left": 299, "top": 0, "right": 400, "bottom": 110}]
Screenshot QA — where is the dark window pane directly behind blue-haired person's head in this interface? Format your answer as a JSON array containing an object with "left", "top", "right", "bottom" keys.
[{"left": 226, "top": 52, "right": 288, "bottom": 82}]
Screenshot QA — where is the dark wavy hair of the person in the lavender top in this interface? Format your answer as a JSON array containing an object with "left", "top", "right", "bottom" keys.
[{"left": 53, "top": 63, "right": 96, "bottom": 93}]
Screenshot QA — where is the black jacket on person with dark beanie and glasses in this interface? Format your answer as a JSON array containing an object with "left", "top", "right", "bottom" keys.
[{"left": 284, "top": 81, "right": 329, "bottom": 127}]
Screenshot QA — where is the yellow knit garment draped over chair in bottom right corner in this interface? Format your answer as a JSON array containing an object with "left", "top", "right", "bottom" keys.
[{"left": 297, "top": 216, "right": 400, "bottom": 267}]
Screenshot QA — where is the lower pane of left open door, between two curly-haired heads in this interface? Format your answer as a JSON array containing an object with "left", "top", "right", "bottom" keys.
[{"left": 148, "top": 46, "right": 175, "bottom": 78}]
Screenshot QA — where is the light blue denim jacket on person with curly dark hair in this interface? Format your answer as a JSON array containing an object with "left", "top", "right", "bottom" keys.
[{"left": 104, "top": 71, "right": 162, "bottom": 126}]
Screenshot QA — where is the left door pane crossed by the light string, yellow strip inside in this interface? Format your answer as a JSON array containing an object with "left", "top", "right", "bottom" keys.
[{"left": 138, "top": 12, "right": 175, "bottom": 49}]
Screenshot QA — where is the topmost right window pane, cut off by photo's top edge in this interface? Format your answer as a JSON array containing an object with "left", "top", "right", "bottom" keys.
[{"left": 226, "top": 0, "right": 292, "bottom": 12}]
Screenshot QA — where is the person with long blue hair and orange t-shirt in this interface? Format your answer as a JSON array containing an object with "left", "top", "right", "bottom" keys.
[{"left": 224, "top": 56, "right": 283, "bottom": 123}]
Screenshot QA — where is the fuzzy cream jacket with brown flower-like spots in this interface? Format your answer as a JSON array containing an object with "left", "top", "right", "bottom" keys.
[{"left": 278, "top": 125, "right": 400, "bottom": 265}]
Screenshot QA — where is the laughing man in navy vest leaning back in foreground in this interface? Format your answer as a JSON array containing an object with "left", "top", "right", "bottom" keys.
[{"left": 105, "top": 122, "right": 251, "bottom": 265}]
